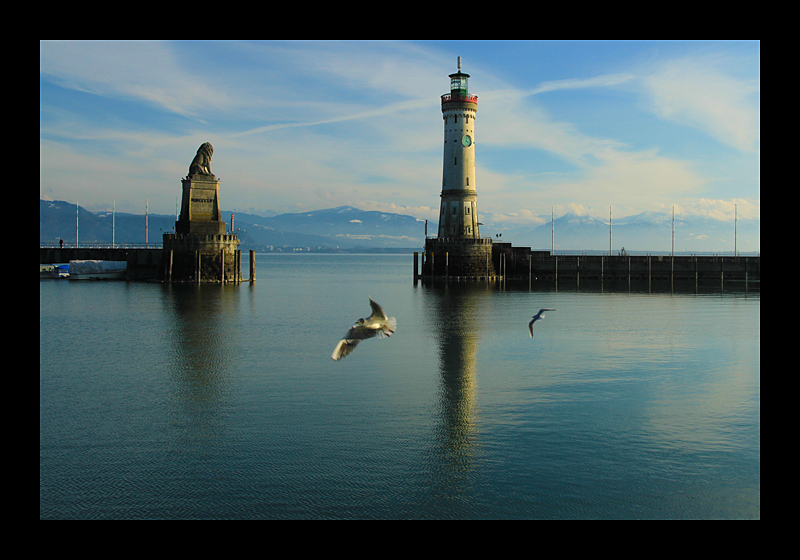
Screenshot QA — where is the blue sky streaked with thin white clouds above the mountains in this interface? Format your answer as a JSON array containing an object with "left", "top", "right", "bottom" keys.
[{"left": 39, "top": 41, "right": 761, "bottom": 227}]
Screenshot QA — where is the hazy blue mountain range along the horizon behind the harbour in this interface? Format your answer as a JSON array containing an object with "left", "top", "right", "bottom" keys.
[{"left": 39, "top": 200, "right": 761, "bottom": 253}]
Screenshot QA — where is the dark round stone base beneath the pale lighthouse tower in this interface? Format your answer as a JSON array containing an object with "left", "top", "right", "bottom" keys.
[{"left": 421, "top": 237, "right": 497, "bottom": 279}]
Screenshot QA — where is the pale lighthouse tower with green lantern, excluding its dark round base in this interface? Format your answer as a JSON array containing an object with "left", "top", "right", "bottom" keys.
[{"left": 438, "top": 57, "right": 480, "bottom": 239}]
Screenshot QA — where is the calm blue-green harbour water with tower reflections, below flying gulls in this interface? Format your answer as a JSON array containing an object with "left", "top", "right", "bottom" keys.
[{"left": 39, "top": 254, "right": 761, "bottom": 519}]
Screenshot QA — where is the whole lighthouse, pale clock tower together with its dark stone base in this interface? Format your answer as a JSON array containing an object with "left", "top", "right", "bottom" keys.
[{"left": 423, "top": 57, "right": 494, "bottom": 278}]
